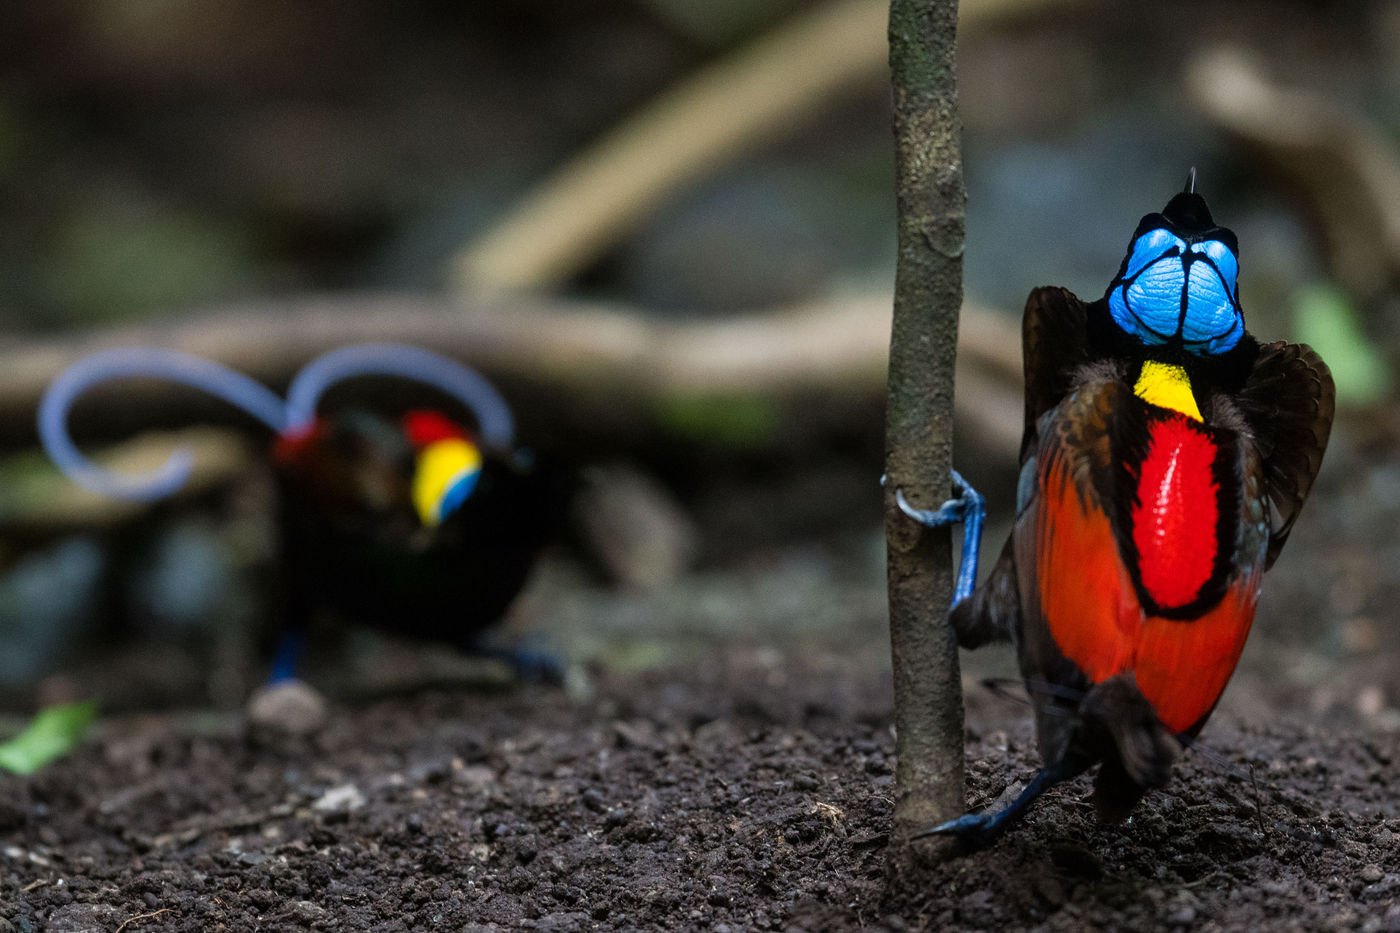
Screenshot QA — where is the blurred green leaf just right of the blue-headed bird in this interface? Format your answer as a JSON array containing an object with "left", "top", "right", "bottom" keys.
[{"left": 1294, "top": 284, "right": 1392, "bottom": 406}]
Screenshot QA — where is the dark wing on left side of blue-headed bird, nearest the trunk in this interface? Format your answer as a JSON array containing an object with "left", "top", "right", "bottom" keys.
[{"left": 1021, "top": 286, "right": 1092, "bottom": 462}]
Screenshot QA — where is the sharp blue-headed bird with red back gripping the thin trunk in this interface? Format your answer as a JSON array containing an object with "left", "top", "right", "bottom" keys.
[{"left": 899, "top": 170, "right": 1334, "bottom": 845}]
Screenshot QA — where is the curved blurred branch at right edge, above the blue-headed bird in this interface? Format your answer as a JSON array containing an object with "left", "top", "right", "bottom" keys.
[{"left": 1187, "top": 48, "right": 1400, "bottom": 303}]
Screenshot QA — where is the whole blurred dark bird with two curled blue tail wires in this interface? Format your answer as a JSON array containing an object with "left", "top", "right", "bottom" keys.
[{"left": 39, "top": 345, "right": 564, "bottom": 682}]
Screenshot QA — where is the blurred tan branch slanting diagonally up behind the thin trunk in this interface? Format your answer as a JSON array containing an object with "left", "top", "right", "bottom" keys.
[{"left": 452, "top": 0, "right": 1075, "bottom": 293}]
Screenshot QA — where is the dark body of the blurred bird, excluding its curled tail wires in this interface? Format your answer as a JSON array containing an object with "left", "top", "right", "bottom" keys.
[{"left": 273, "top": 410, "right": 566, "bottom": 679}]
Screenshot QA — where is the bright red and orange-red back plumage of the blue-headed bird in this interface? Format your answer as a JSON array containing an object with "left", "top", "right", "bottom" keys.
[{"left": 1018, "top": 403, "right": 1263, "bottom": 734}]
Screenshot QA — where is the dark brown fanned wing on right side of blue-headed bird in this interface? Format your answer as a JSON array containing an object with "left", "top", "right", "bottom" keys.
[{"left": 1235, "top": 340, "right": 1337, "bottom": 569}]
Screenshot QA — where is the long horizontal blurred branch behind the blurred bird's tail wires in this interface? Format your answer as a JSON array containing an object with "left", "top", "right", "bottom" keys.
[{"left": 0, "top": 296, "right": 1021, "bottom": 452}]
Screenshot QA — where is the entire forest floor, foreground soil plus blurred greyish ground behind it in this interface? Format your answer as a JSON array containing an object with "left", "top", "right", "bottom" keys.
[{"left": 0, "top": 423, "right": 1400, "bottom": 933}]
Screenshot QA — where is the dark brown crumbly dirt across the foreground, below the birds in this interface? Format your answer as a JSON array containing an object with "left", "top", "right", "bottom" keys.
[{"left": 0, "top": 638, "right": 1400, "bottom": 933}]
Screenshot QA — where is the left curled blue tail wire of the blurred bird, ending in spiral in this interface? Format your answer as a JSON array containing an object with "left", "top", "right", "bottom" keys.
[{"left": 39, "top": 347, "right": 287, "bottom": 502}]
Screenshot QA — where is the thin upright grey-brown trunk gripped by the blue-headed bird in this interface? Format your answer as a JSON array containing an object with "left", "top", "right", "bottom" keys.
[{"left": 885, "top": 0, "right": 966, "bottom": 867}]
